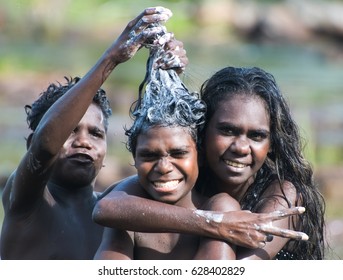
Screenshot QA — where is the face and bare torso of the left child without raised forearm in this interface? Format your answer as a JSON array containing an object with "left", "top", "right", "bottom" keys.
[{"left": 1, "top": 105, "right": 106, "bottom": 259}]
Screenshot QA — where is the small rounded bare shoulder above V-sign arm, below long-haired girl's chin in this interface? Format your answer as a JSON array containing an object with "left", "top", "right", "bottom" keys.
[{"left": 205, "top": 193, "right": 241, "bottom": 212}]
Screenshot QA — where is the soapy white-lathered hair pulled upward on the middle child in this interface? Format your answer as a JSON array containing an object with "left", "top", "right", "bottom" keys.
[{"left": 125, "top": 34, "right": 206, "bottom": 156}]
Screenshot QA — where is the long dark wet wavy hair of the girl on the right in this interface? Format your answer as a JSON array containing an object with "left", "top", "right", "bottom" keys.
[{"left": 201, "top": 67, "right": 325, "bottom": 259}]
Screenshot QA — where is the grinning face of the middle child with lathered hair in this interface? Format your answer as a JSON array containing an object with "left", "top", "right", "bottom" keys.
[{"left": 135, "top": 126, "right": 198, "bottom": 206}]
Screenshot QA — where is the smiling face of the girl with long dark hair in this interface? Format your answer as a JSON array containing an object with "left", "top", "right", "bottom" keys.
[{"left": 205, "top": 94, "right": 270, "bottom": 199}]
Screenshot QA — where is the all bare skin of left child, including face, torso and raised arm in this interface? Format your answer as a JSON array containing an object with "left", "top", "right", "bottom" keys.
[{"left": 1, "top": 8, "right": 182, "bottom": 260}]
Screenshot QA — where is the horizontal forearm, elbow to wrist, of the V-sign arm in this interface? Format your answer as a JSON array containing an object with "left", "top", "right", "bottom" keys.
[{"left": 93, "top": 191, "right": 218, "bottom": 237}]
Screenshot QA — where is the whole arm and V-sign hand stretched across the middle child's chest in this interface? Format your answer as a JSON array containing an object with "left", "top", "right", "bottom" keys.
[{"left": 93, "top": 176, "right": 308, "bottom": 248}]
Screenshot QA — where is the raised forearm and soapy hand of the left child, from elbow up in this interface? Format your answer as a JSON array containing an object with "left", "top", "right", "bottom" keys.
[{"left": 34, "top": 8, "right": 171, "bottom": 155}]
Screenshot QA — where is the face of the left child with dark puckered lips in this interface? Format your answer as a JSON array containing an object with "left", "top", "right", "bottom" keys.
[{"left": 52, "top": 104, "right": 107, "bottom": 187}]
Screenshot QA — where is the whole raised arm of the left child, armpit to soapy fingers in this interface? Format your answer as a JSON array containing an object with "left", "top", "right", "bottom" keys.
[{"left": 4, "top": 7, "right": 175, "bottom": 213}]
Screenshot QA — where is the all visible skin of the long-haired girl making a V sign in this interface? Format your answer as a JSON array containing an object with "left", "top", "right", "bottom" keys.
[{"left": 93, "top": 93, "right": 307, "bottom": 259}]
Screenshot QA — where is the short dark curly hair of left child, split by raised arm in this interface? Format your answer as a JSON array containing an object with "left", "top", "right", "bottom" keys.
[{"left": 25, "top": 77, "right": 112, "bottom": 131}]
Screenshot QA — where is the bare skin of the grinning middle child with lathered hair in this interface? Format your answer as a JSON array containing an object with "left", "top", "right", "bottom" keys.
[{"left": 95, "top": 126, "right": 239, "bottom": 260}]
